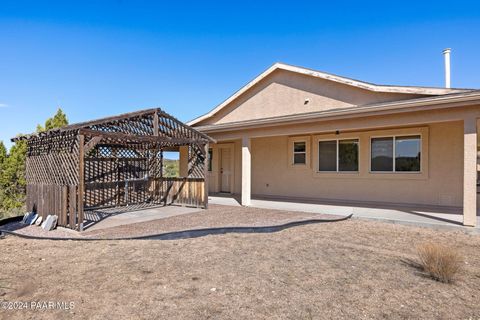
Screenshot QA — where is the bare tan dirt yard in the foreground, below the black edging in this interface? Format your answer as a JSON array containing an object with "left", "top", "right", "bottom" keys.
[{"left": 0, "top": 206, "right": 480, "bottom": 319}]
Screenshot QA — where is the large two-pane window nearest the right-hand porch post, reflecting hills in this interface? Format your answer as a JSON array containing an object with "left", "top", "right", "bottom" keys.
[{"left": 371, "top": 136, "right": 421, "bottom": 172}]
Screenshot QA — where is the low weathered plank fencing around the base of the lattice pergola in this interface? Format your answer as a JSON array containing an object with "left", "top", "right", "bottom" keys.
[{"left": 26, "top": 178, "right": 207, "bottom": 228}]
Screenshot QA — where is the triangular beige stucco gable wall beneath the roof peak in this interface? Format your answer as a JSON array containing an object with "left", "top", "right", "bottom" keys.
[{"left": 201, "top": 70, "right": 421, "bottom": 126}]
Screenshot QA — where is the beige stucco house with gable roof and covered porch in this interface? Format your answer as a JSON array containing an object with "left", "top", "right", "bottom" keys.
[{"left": 189, "top": 63, "right": 480, "bottom": 226}]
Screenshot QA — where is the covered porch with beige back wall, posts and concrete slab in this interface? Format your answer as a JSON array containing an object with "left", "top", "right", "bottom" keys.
[{"left": 205, "top": 112, "right": 480, "bottom": 227}]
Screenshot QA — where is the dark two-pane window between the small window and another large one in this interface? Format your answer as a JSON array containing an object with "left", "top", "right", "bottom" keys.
[{"left": 318, "top": 139, "right": 358, "bottom": 172}]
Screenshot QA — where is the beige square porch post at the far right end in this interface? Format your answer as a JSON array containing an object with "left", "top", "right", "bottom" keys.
[{"left": 463, "top": 117, "right": 477, "bottom": 227}]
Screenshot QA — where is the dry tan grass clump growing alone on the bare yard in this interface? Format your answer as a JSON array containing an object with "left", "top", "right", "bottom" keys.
[{"left": 417, "top": 242, "right": 462, "bottom": 283}]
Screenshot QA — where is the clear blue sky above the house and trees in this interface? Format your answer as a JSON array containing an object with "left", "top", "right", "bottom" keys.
[{"left": 0, "top": 0, "right": 480, "bottom": 149}]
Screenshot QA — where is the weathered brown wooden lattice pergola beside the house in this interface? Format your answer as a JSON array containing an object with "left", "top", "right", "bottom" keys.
[{"left": 12, "top": 108, "right": 214, "bottom": 230}]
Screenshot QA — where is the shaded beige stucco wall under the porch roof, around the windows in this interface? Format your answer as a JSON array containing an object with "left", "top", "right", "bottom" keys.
[{"left": 246, "top": 122, "right": 463, "bottom": 206}]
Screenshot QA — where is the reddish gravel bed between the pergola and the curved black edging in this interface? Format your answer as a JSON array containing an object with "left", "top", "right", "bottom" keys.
[{"left": 1, "top": 205, "right": 339, "bottom": 238}]
